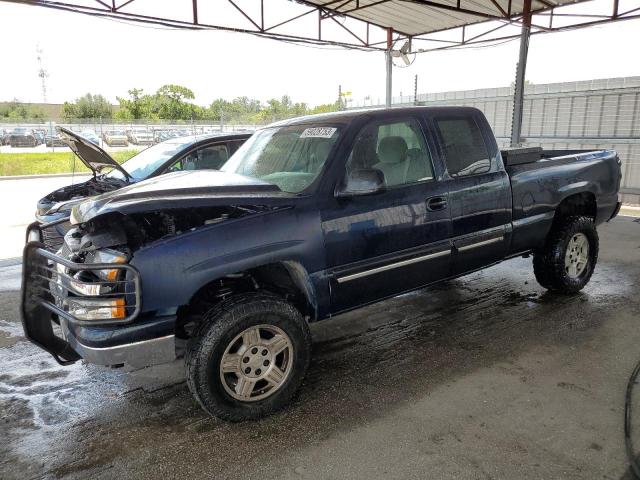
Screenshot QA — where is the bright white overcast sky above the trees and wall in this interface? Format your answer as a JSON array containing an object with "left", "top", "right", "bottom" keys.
[{"left": 0, "top": 0, "right": 640, "bottom": 105}]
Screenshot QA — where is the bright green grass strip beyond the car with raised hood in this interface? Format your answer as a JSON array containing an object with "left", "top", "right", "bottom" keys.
[{"left": 0, "top": 150, "right": 138, "bottom": 176}]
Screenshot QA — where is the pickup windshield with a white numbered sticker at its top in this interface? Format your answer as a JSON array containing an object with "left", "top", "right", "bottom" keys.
[{"left": 221, "top": 125, "right": 340, "bottom": 193}]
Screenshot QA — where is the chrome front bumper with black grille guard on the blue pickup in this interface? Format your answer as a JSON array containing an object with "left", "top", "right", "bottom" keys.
[{"left": 21, "top": 241, "right": 176, "bottom": 367}]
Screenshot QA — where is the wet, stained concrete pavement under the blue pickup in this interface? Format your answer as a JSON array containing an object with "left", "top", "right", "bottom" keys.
[{"left": 0, "top": 217, "right": 640, "bottom": 479}]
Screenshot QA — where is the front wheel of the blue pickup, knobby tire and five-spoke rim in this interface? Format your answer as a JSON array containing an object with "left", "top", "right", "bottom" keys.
[{"left": 185, "top": 293, "right": 311, "bottom": 422}]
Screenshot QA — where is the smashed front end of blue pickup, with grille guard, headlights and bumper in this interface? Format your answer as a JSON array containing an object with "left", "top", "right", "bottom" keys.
[{"left": 21, "top": 206, "right": 275, "bottom": 367}]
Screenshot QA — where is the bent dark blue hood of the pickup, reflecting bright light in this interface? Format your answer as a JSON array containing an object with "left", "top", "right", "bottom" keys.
[{"left": 71, "top": 170, "right": 295, "bottom": 224}]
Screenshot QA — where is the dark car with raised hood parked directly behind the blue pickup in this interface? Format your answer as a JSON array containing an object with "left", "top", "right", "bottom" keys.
[{"left": 36, "top": 127, "right": 251, "bottom": 249}]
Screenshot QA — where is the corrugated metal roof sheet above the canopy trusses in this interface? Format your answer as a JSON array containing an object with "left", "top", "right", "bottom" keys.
[{"left": 305, "top": 0, "right": 588, "bottom": 36}]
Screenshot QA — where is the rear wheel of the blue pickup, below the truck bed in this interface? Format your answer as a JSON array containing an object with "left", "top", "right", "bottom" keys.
[{"left": 533, "top": 217, "right": 599, "bottom": 294}]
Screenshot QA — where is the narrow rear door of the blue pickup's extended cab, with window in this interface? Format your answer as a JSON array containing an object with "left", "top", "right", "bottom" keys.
[{"left": 431, "top": 108, "right": 512, "bottom": 274}]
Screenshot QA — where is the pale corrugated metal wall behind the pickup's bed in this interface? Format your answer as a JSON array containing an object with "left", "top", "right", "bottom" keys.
[{"left": 354, "top": 77, "right": 640, "bottom": 203}]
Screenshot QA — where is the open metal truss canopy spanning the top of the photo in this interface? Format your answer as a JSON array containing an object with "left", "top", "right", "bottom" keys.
[{"left": 5, "top": 0, "right": 640, "bottom": 52}]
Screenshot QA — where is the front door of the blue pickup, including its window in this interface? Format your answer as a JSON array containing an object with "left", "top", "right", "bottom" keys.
[{"left": 322, "top": 115, "right": 451, "bottom": 313}]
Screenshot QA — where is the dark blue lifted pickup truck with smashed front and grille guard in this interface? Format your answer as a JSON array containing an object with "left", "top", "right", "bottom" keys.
[{"left": 22, "top": 107, "right": 621, "bottom": 421}]
